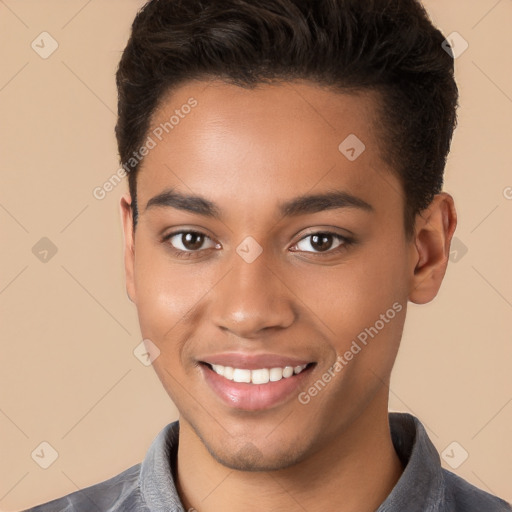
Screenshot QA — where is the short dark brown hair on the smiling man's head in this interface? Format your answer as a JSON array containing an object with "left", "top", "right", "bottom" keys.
[{"left": 116, "top": 0, "right": 458, "bottom": 235}]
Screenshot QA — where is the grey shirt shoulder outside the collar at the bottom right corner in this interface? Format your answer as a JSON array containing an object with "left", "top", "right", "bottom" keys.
[{"left": 443, "top": 469, "right": 512, "bottom": 512}]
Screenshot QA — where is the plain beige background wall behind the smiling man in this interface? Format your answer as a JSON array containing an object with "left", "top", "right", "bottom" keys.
[{"left": 0, "top": 0, "right": 512, "bottom": 511}]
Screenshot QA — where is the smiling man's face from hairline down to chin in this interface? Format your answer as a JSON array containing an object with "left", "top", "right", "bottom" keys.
[{"left": 122, "top": 81, "right": 440, "bottom": 470}]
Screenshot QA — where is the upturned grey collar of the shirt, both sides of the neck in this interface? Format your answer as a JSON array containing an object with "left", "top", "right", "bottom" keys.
[{"left": 139, "top": 412, "right": 444, "bottom": 512}]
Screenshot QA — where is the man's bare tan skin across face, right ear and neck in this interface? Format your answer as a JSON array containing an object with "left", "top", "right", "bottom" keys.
[{"left": 121, "top": 80, "right": 456, "bottom": 512}]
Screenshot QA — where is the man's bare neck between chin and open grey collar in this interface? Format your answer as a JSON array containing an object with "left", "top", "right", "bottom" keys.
[{"left": 177, "top": 394, "right": 403, "bottom": 512}]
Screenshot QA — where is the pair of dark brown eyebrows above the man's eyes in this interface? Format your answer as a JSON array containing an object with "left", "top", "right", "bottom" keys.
[{"left": 145, "top": 189, "right": 375, "bottom": 219}]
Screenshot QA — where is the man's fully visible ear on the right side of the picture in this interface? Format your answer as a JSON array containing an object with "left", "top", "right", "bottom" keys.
[{"left": 409, "top": 192, "right": 457, "bottom": 304}]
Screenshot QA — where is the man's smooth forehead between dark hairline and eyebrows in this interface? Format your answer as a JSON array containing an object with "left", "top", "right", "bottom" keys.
[{"left": 137, "top": 80, "right": 401, "bottom": 219}]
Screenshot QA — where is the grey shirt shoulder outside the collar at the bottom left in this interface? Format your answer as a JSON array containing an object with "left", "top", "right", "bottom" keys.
[{"left": 23, "top": 463, "right": 147, "bottom": 512}]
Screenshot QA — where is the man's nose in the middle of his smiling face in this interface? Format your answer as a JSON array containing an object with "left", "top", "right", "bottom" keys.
[{"left": 211, "top": 249, "right": 297, "bottom": 339}]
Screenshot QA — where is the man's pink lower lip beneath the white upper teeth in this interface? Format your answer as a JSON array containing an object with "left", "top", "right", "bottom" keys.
[{"left": 200, "top": 364, "right": 313, "bottom": 411}]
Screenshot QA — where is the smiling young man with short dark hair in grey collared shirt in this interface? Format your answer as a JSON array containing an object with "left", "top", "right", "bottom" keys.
[{"left": 25, "top": 0, "right": 512, "bottom": 512}]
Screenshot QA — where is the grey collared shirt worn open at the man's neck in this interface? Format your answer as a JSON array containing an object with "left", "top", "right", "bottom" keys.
[{"left": 24, "top": 413, "right": 512, "bottom": 512}]
